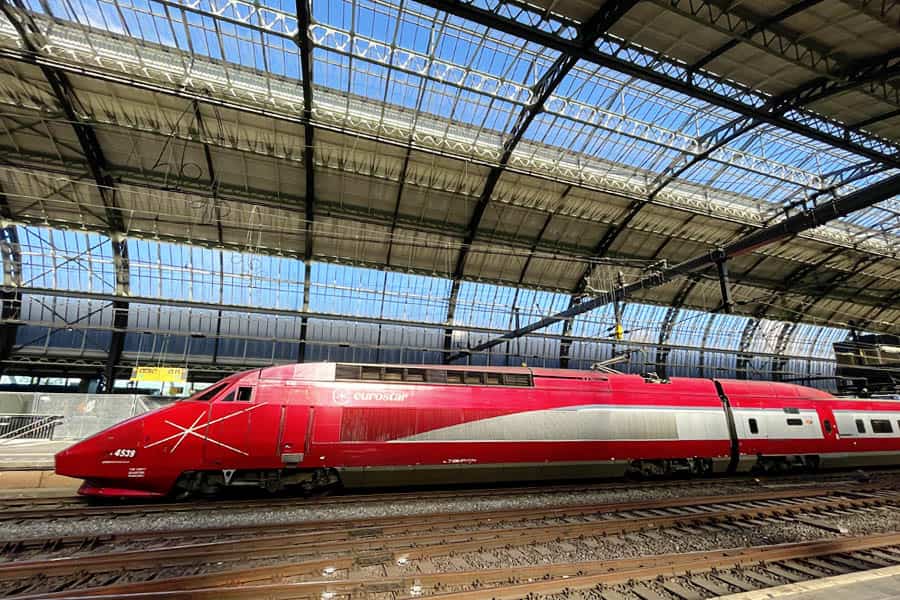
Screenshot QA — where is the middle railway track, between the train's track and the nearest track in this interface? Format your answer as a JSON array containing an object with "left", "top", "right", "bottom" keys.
[{"left": 0, "top": 486, "right": 900, "bottom": 598}]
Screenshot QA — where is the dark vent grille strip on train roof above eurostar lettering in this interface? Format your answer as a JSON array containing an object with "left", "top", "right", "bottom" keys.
[{"left": 334, "top": 364, "right": 534, "bottom": 387}]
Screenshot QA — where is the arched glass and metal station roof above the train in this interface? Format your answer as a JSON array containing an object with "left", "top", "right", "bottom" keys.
[{"left": 0, "top": 0, "right": 900, "bottom": 390}]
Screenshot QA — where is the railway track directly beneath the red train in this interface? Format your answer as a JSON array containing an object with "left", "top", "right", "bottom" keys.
[{"left": 0, "top": 469, "right": 888, "bottom": 522}]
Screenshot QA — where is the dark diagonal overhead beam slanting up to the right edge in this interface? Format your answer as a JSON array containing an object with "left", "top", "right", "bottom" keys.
[{"left": 451, "top": 175, "right": 900, "bottom": 360}]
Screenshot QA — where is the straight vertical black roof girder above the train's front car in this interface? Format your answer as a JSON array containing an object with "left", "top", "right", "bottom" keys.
[{"left": 294, "top": 0, "right": 316, "bottom": 363}]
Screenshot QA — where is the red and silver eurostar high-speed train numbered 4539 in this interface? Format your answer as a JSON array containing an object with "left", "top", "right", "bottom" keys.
[{"left": 56, "top": 363, "right": 900, "bottom": 496}]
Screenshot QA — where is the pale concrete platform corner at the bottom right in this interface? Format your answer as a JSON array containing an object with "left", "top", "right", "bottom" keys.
[{"left": 719, "top": 566, "right": 900, "bottom": 600}]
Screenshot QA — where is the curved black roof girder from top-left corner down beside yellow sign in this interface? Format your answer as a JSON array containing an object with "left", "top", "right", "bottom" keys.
[{"left": 0, "top": 0, "right": 130, "bottom": 393}]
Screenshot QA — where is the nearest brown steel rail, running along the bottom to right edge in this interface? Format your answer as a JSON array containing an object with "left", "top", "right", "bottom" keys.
[{"left": 18, "top": 533, "right": 900, "bottom": 600}]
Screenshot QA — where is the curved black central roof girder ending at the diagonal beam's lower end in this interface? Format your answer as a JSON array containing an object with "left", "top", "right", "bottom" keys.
[{"left": 444, "top": 0, "right": 638, "bottom": 362}]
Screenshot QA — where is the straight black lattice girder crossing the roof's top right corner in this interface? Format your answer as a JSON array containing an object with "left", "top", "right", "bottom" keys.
[{"left": 414, "top": 0, "right": 900, "bottom": 167}]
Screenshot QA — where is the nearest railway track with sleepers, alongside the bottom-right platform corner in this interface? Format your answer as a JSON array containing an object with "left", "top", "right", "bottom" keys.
[{"left": 24, "top": 533, "right": 900, "bottom": 600}]
